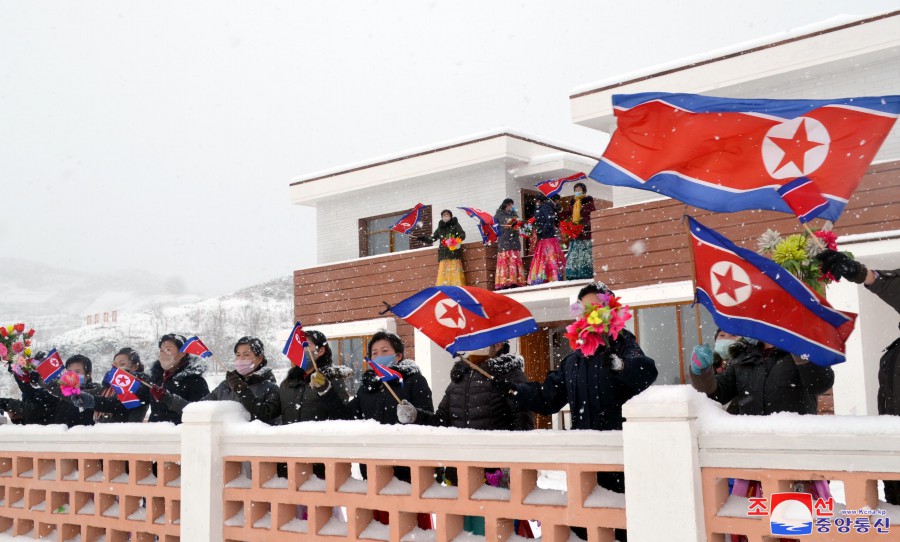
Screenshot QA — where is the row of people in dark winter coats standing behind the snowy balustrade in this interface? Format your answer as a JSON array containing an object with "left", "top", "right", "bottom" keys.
[{"left": 0, "top": 249, "right": 900, "bottom": 540}]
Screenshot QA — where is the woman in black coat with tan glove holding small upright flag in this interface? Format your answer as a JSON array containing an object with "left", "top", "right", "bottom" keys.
[{"left": 278, "top": 329, "right": 353, "bottom": 425}]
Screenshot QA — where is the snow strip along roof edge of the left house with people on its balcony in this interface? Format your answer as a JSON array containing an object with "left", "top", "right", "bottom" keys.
[{"left": 290, "top": 126, "right": 600, "bottom": 185}]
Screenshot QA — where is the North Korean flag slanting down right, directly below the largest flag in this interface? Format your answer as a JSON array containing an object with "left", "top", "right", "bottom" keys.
[{"left": 688, "top": 217, "right": 856, "bottom": 365}]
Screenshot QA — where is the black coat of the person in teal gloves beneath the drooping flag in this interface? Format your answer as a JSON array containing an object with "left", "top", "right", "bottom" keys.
[{"left": 691, "top": 343, "right": 834, "bottom": 415}]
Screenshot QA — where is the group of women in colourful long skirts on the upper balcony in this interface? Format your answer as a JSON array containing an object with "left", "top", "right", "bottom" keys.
[{"left": 418, "top": 183, "right": 595, "bottom": 290}]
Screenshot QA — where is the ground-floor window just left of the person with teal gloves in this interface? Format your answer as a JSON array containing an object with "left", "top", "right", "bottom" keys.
[{"left": 629, "top": 303, "right": 716, "bottom": 384}]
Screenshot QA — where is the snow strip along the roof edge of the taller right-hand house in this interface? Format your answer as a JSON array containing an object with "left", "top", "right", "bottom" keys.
[{"left": 571, "top": 12, "right": 900, "bottom": 98}]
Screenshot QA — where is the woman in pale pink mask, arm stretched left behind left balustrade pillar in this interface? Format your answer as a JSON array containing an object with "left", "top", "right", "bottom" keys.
[{"left": 163, "top": 336, "right": 281, "bottom": 424}]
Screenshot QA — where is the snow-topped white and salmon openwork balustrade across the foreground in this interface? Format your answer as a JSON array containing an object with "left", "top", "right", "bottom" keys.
[{"left": 0, "top": 392, "right": 900, "bottom": 542}]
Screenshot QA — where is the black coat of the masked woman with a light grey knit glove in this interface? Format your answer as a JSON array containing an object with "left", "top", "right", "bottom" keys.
[{"left": 347, "top": 359, "right": 434, "bottom": 425}]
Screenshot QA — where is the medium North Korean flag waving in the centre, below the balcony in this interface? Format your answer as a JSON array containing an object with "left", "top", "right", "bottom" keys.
[{"left": 391, "top": 286, "right": 538, "bottom": 356}]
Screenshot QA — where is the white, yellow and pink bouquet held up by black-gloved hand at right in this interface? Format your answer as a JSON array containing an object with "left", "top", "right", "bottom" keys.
[{"left": 757, "top": 230, "right": 837, "bottom": 296}]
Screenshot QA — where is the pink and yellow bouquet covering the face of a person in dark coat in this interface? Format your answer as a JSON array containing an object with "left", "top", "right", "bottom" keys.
[{"left": 564, "top": 294, "right": 631, "bottom": 362}]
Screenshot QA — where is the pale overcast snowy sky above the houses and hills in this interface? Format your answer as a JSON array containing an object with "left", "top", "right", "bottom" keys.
[{"left": 0, "top": 0, "right": 896, "bottom": 294}]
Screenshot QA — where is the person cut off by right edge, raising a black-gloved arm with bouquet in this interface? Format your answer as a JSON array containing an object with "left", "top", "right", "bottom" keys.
[{"left": 816, "top": 250, "right": 900, "bottom": 505}]
